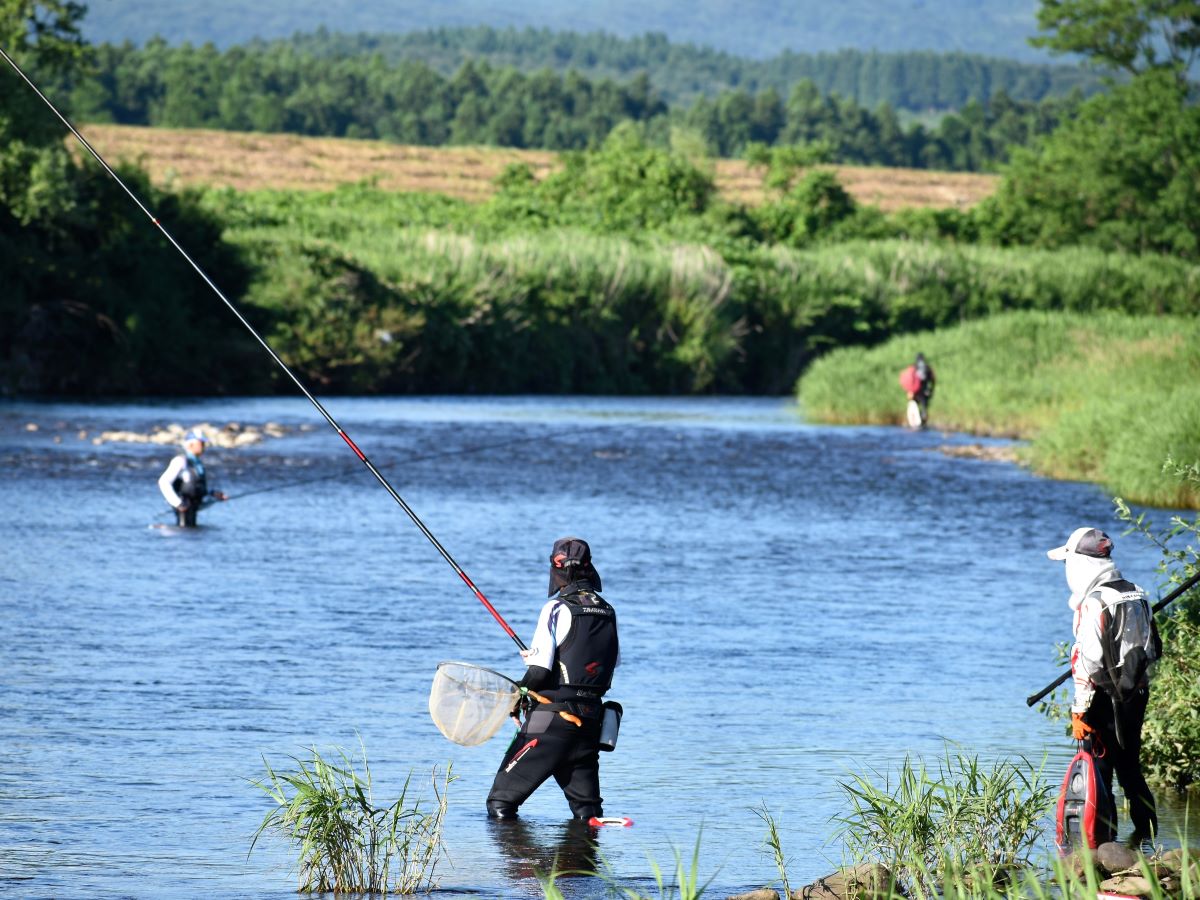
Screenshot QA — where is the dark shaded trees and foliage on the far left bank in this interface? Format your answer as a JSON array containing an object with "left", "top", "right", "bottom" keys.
[{"left": 0, "top": 0, "right": 262, "bottom": 395}]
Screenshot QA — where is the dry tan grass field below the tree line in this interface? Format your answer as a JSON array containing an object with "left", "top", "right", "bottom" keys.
[{"left": 80, "top": 125, "right": 996, "bottom": 211}]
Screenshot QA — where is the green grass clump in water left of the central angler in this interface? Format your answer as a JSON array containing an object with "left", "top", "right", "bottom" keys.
[{"left": 251, "top": 749, "right": 454, "bottom": 894}]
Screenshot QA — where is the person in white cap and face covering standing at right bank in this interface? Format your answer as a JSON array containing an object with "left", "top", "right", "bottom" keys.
[{"left": 1046, "top": 528, "right": 1163, "bottom": 850}]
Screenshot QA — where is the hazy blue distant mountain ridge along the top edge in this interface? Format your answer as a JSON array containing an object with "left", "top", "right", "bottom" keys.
[{"left": 84, "top": 0, "right": 1049, "bottom": 62}]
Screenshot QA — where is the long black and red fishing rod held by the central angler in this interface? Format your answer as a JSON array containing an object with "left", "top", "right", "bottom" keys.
[{"left": 0, "top": 47, "right": 528, "bottom": 650}]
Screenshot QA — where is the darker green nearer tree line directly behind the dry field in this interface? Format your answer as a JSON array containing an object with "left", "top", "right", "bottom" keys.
[{"left": 55, "top": 40, "right": 1080, "bottom": 170}]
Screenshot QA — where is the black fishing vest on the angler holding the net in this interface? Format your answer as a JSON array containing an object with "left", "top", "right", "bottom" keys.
[{"left": 542, "top": 590, "right": 620, "bottom": 702}]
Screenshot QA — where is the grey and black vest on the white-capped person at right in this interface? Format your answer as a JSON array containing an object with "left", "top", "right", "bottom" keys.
[{"left": 1092, "top": 578, "right": 1163, "bottom": 703}]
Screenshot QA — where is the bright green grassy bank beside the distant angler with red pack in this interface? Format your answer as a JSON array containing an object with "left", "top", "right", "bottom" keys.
[{"left": 798, "top": 312, "right": 1200, "bottom": 506}]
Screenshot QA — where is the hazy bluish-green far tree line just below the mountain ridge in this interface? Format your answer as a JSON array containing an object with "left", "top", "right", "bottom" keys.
[{"left": 280, "top": 25, "right": 1103, "bottom": 113}]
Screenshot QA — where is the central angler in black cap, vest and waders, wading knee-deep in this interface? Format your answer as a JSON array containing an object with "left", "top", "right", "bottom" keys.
[{"left": 487, "top": 538, "right": 619, "bottom": 821}]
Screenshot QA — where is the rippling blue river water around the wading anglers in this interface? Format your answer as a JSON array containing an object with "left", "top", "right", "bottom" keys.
[{"left": 0, "top": 398, "right": 1182, "bottom": 898}]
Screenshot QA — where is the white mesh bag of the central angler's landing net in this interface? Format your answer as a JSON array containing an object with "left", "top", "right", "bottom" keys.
[{"left": 430, "top": 662, "right": 521, "bottom": 746}]
